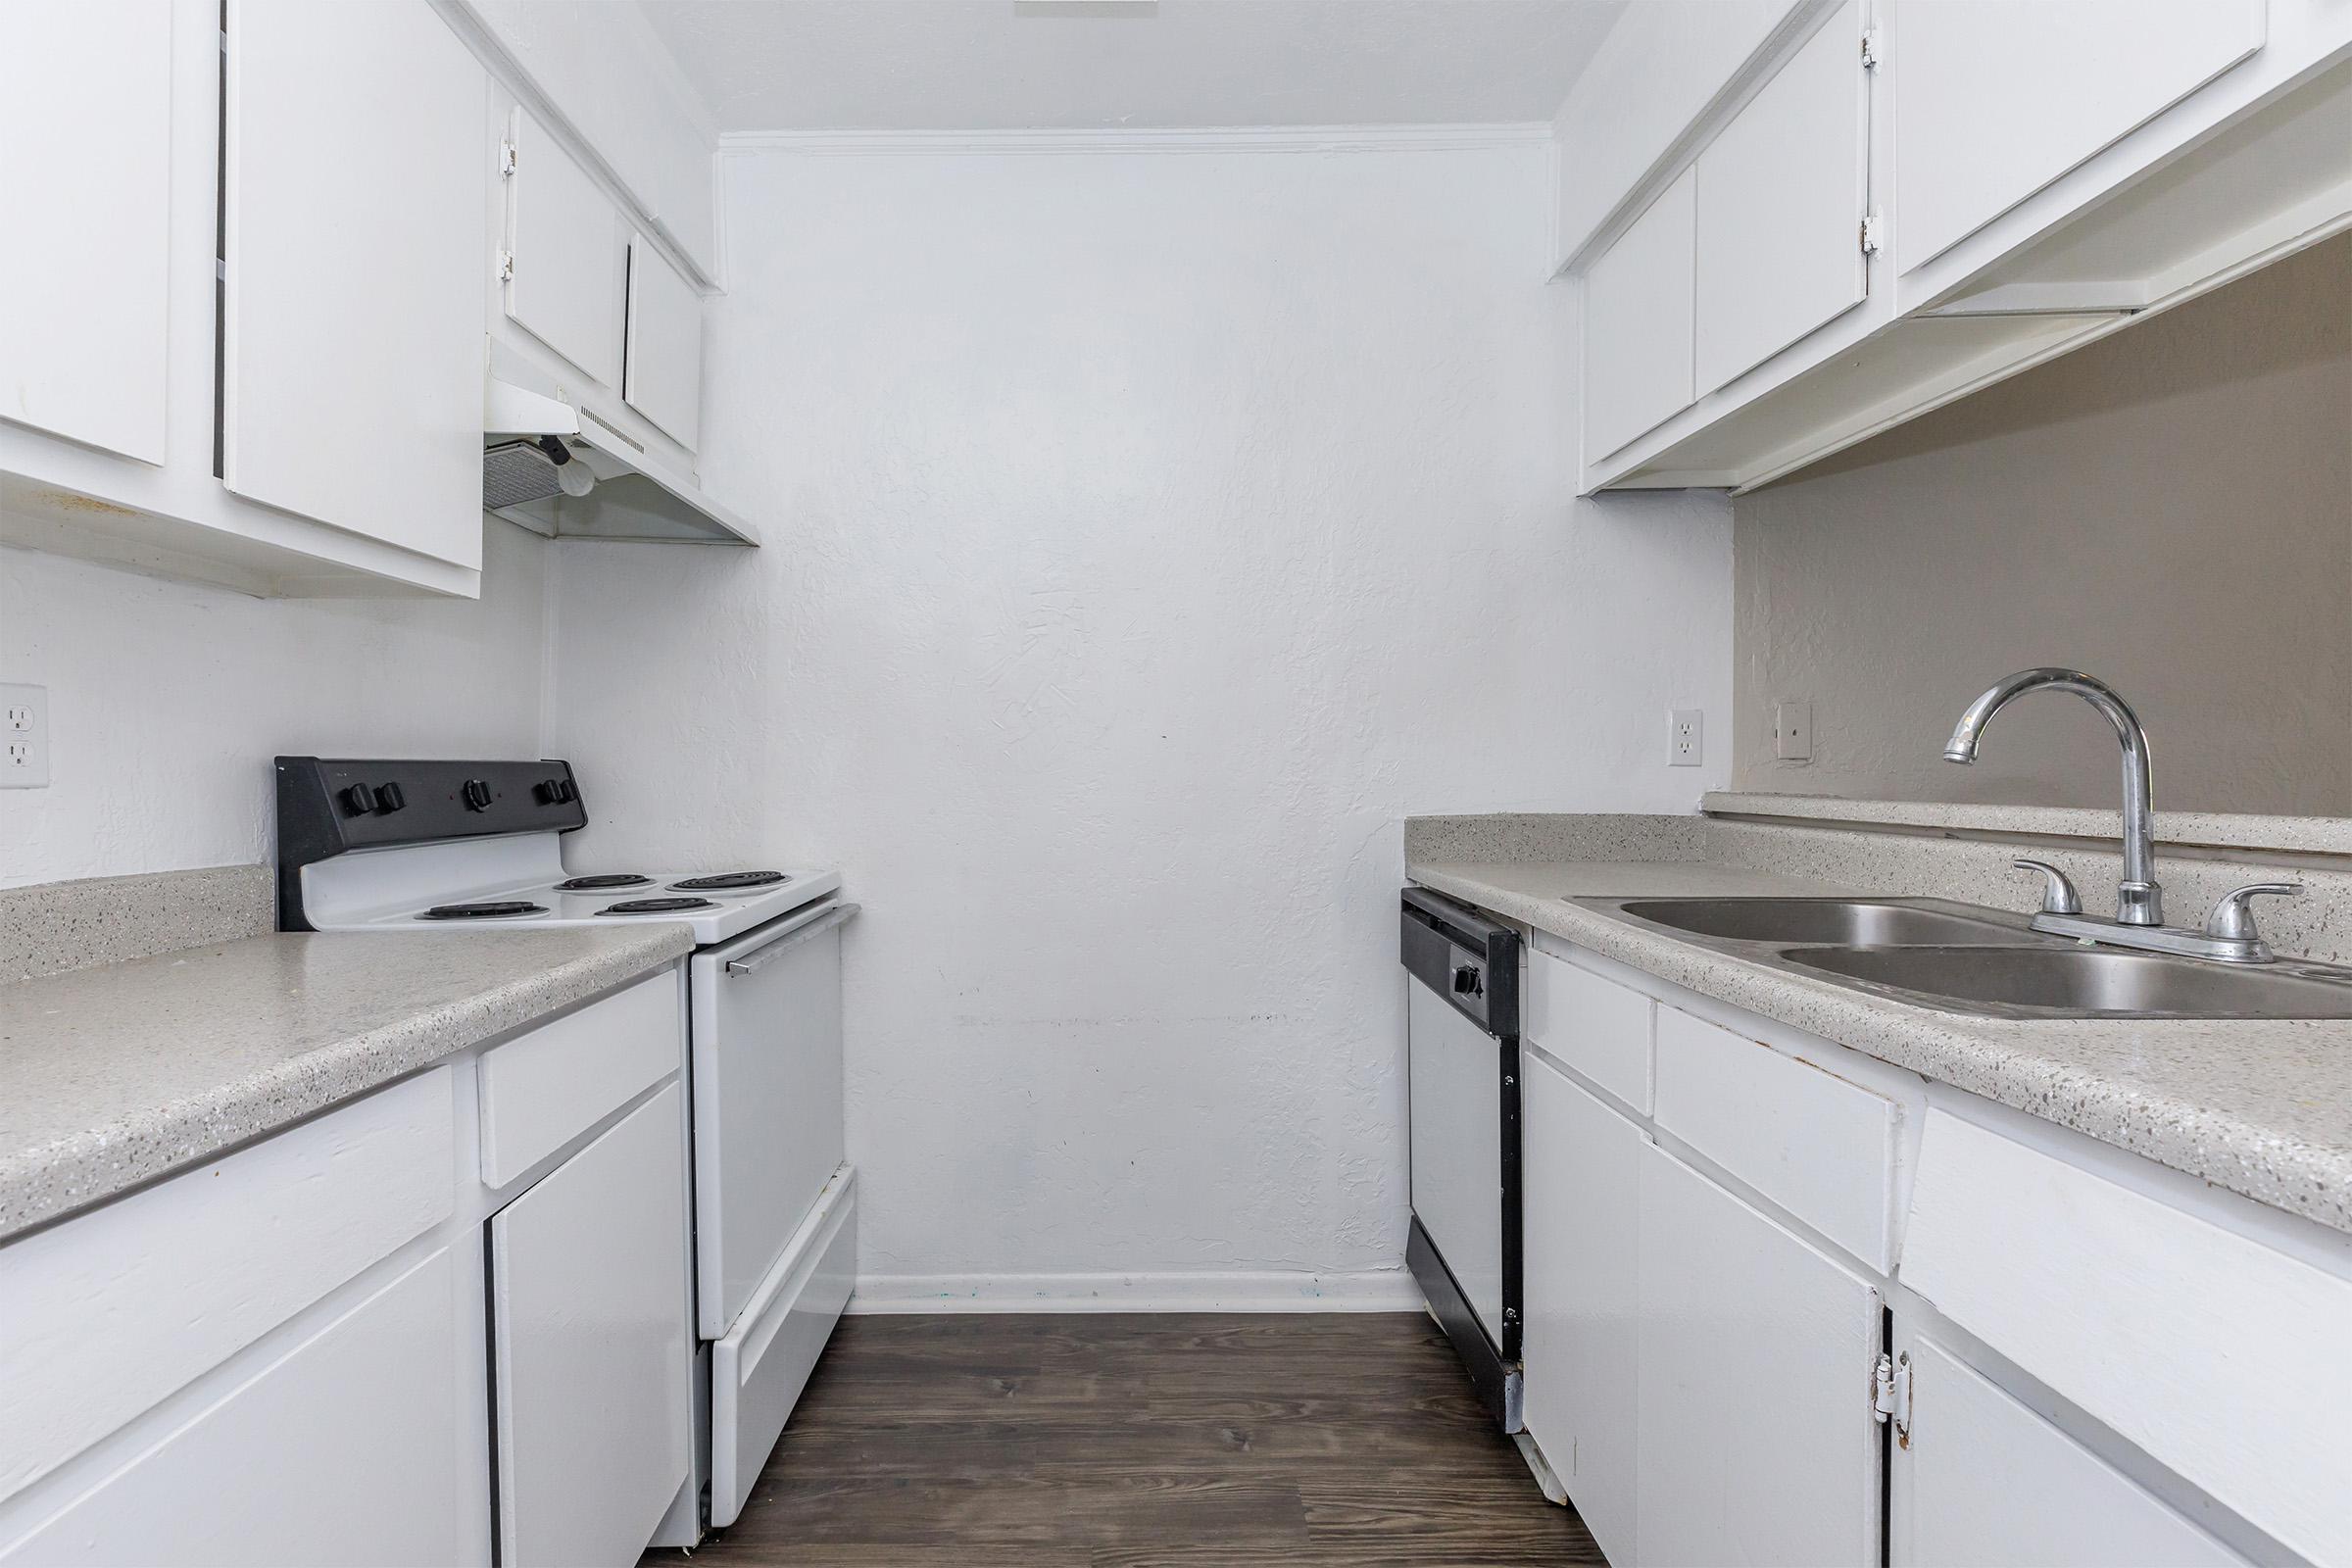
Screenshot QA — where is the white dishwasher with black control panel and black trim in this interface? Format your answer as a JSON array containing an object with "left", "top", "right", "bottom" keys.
[{"left": 1397, "top": 886, "right": 1522, "bottom": 1432}]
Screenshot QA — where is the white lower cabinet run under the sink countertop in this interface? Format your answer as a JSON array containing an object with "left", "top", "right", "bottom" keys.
[{"left": 1522, "top": 948, "right": 2352, "bottom": 1568}]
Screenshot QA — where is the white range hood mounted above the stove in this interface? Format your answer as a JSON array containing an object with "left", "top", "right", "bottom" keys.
[{"left": 482, "top": 346, "right": 760, "bottom": 546}]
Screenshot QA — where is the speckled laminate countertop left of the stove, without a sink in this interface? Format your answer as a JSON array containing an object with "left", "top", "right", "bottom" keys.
[{"left": 0, "top": 921, "right": 694, "bottom": 1239}]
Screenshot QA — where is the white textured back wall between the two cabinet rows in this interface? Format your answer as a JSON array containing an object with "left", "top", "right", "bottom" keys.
[{"left": 551, "top": 146, "right": 1731, "bottom": 1304}]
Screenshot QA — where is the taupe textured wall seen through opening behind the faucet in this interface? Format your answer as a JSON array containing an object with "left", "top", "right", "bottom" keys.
[{"left": 1734, "top": 237, "right": 2352, "bottom": 815}]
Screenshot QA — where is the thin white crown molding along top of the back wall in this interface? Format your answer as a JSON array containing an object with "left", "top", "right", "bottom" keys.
[{"left": 719, "top": 120, "right": 1552, "bottom": 158}]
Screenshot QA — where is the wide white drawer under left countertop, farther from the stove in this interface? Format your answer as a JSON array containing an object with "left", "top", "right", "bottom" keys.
[{"left": 0, "top": 1067, "right": 457, "bottom": 1497}]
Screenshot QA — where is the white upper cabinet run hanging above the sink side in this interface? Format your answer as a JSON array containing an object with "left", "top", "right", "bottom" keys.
[{"left": 1554, "top": 0, "right": 2352, "bottom": 494}]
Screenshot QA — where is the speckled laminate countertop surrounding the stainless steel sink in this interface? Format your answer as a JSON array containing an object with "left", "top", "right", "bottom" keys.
[{"left": 1406, "top": 858, "right": 2352, "bottom": 1232}]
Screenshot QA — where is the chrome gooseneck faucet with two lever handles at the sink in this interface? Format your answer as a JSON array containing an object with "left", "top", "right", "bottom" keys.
[{"left": 1942, "top": 667, "right": 2303, "bottom": 964}]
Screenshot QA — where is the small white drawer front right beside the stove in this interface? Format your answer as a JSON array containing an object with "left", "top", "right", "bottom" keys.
[{"left": 482, "top": 971, "right": 684, "bottom": 1187}]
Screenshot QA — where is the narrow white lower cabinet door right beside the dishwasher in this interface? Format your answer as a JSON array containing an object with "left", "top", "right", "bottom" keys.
[{"left": 1519, "top": 1054, "right": 1644, "bottom": 1563}]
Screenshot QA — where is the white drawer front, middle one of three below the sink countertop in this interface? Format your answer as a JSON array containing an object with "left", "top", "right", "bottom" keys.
[{"left": 1658, "top": 1006, "right": 1903, "bottom": 1272}]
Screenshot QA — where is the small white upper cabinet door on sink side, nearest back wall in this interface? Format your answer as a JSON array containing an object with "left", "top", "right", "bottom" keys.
[{"left": 1586, "top": 172, "right": 1691, "bottom": 464}]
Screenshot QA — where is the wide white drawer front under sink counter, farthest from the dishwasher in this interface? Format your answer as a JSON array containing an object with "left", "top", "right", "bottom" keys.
[{"left": 1903, "top": 1109, "right": 2352, "bottom": 1563}]
